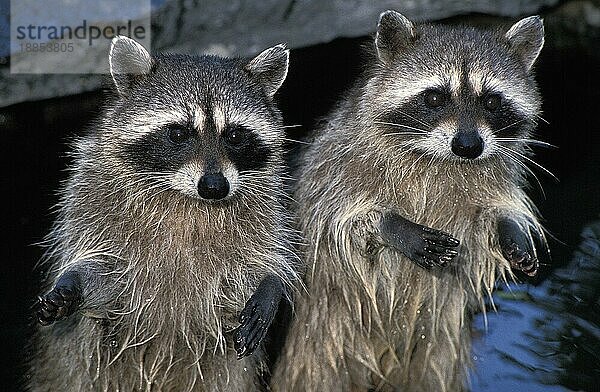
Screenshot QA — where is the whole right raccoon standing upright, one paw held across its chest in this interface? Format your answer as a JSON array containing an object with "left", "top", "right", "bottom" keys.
[{"left": 272, "top": 11, "right": 545, "bottom": 391}]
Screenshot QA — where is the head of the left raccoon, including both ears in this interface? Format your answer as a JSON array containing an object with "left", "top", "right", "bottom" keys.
[{"left": 110, "top": 37, "right": 289, "bottom": 200}]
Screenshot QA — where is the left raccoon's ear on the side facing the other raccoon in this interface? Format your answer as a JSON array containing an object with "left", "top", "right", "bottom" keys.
[{"left": 244, "top": 44, "right": 290, "bottom": 97}]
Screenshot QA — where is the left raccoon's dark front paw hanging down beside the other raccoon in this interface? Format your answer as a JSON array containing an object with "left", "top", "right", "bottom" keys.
[{"left": 233, "top": 276, "right": 283, "bottom": 359}]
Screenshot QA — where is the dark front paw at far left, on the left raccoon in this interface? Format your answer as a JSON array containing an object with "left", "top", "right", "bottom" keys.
[{"left": 37, "top": 286, "right": 80, "bottom": 325}]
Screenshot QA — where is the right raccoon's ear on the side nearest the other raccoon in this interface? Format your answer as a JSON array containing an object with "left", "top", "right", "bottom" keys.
[{"left": 375, "top": 10, "right": 416, "bottom": 64}]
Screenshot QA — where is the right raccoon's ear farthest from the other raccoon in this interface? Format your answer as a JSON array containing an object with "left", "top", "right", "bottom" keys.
[{"left": 506, "top": 15, "right": 544, "bottom": 71}]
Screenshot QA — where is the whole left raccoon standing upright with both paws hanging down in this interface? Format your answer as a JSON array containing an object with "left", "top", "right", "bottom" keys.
[{"left": 28, "top": 36, "right": 299, "bottom": 391}]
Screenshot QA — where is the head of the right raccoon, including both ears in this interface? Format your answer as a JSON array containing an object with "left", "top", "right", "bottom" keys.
[{"left": 371, "top": 11, "right": 544, "bottom": 161}]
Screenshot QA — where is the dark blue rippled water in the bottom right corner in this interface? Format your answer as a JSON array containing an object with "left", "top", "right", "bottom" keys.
[{"left": 471, "top": 221, "right": 600, "bottom": 392}]
